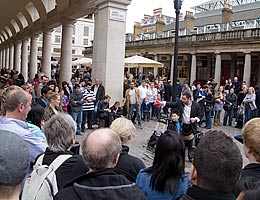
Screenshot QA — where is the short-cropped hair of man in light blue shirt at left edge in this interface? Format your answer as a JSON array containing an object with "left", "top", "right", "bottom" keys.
[{"left": 1, "top": 85, "right": 28, "bottom": 114}]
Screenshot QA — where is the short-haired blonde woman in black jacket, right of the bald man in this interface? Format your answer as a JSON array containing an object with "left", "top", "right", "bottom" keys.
[{"left": 110, "top": 117, "right": 145, "bottom": 182}]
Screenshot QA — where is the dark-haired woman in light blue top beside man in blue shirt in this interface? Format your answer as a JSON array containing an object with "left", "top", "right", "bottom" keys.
[{"left": 26, "top": 103, "right": 47, "bottom": 143}]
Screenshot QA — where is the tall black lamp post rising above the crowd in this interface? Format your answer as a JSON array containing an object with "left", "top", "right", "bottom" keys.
[{"left": 172, "top": 0, "right": 182, "bottom": 102}]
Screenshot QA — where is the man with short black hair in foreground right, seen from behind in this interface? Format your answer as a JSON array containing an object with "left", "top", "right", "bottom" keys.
[{"left": 187, "top": 130, "right": 242, "bottom": 200}]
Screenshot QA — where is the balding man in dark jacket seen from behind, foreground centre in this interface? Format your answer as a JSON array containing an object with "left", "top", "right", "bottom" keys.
[{"left": 54, "top": 129, "right": 146, "bottom": 200}]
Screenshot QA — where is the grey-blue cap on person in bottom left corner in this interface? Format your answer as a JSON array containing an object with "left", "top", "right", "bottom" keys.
[{"left": 0, "top": 130, "right": 29, "bottom": 186}]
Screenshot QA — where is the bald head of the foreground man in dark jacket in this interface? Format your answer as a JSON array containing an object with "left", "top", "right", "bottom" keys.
[{"left": 82, "top": 129, "right": 121, "bottom": 170}]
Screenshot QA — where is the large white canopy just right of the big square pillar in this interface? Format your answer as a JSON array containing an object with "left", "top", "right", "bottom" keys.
[{"left": 125, "top": 55, "right": 163, "bottom": 68}]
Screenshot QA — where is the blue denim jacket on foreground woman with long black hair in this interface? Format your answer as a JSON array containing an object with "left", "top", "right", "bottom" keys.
[{"left": 136, "top": 169, "right": 189, "bottom": 200}]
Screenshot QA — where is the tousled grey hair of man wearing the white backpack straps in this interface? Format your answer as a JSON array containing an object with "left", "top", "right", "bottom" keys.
[{"left": 44, "top": 113, "right": 76, "bottom": 152}]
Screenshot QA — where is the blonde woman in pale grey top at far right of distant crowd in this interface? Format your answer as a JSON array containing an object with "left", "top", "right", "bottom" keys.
[{"left": 243, "top": 87, "right": 257, "bottom": 123}]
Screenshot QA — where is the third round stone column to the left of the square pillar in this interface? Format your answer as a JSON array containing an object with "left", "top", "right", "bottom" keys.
[{"left": 29, "top": 34, "right": 39, "bottom": 80}]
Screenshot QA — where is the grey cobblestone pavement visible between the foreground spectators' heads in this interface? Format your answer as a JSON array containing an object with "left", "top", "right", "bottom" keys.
[{"left": 76, "top": 120, "right": 248, "bottom": 172}]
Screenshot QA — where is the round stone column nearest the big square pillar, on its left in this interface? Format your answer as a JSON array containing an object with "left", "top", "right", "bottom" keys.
[{"left": 59, "top": 20, "right": 73, "bottom": 83}]
